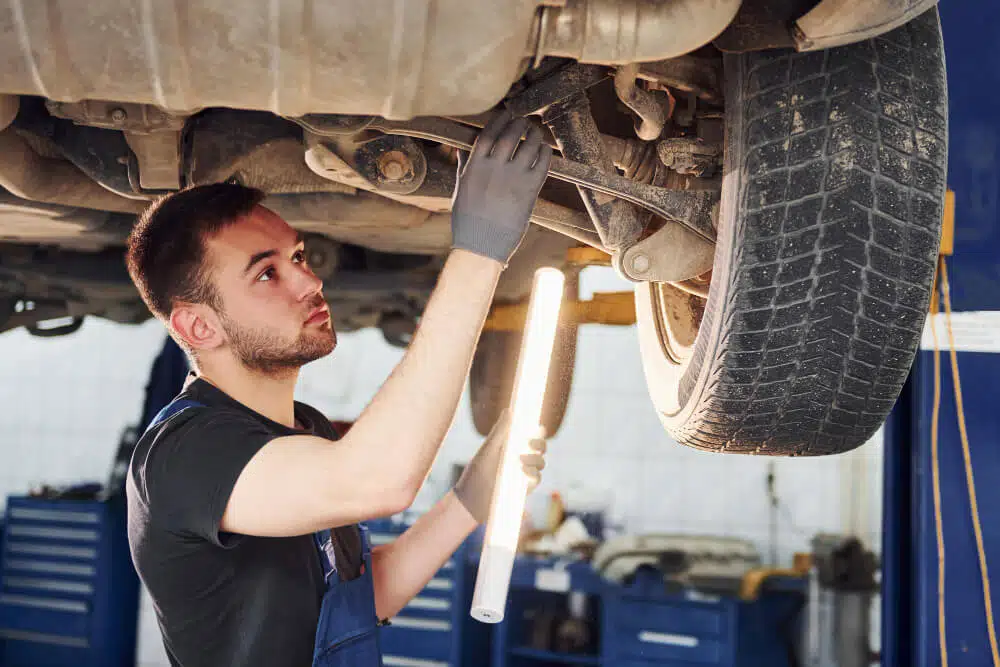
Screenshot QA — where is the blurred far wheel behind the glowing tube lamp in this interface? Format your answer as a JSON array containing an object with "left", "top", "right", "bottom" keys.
[{"left": 469, "top": 273, "right": 580, "bottom": 437}]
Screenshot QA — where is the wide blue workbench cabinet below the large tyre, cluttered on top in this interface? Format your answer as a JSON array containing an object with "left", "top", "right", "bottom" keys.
[{"left": 490, "top": 558, "right": 804, "bottom": 667}]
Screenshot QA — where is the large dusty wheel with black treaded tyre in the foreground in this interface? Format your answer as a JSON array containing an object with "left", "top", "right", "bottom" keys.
[{"left": 635, "top": 9, "right": 947, "bottom": 455}]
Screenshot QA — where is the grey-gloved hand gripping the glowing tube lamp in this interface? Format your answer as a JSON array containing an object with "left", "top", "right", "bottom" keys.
[{"left": 453, "top": 410, "right": 546, "bottom": 523}]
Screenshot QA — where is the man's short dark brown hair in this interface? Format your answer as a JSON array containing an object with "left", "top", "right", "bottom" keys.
[{"left": 125, "top": 183, "right": 265, "bottom": 320}]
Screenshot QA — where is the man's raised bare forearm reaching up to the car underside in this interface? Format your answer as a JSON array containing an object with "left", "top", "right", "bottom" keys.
[{"left": 349, "top": 250, "right": 502, "bottom": 494}]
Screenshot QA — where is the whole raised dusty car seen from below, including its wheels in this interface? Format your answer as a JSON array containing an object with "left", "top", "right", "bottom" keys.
[{"left": 0, "top": 0, "right": 946, "bottom": 455}]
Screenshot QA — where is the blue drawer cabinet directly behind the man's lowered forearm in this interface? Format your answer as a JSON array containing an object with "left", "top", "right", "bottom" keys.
[{"left": 366, "top": 519, "right": 489, "bottom": 667}]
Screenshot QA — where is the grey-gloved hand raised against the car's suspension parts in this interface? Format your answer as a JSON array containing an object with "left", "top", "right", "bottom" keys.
[{"left": 451, "top": 111, "right": 552, "bottom": 266}]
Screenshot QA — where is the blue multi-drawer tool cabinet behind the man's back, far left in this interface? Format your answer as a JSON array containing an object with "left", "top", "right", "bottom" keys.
[{"left": 0, "top": 496, "right": 139, "bottom": 667}]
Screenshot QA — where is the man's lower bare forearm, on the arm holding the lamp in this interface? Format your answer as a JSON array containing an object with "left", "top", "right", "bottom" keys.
[{"left": 372, "top": 492, "right": 478, "bottom": 618}]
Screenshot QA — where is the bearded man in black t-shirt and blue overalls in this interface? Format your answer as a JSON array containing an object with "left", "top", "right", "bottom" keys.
[{"left": 126, "top": 112, "right": 552, "bottom": 667}]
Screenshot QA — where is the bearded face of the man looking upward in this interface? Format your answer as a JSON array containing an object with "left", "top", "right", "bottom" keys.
[{"left": 205, "top": 206, "right": 337, "bottom": 374}]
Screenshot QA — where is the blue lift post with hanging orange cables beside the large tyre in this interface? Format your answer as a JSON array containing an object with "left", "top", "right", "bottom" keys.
[{"left": 881, "top": 2, "right": 1000, "bottom": 667}]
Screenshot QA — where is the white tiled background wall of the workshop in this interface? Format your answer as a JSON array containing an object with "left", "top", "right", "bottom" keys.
[{"left": 0, "top": 269, "right": 881, "bottom": 667}]
